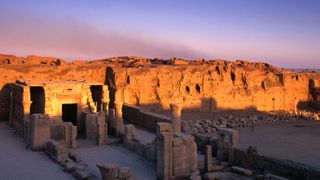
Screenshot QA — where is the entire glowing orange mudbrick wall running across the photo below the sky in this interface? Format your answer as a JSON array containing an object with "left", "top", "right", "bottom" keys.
[{"left": 0, "top": 55, "right": 320, "bottom": 120}]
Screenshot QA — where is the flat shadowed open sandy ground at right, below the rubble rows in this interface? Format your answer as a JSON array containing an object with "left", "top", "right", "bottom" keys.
[{"left": 238, "top": 121, "right": 320, "bottom": 168}]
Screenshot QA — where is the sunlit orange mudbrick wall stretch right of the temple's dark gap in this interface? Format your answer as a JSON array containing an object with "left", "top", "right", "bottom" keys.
[{"left": 110, "top": 63, "right": 320, "bottom": 112}]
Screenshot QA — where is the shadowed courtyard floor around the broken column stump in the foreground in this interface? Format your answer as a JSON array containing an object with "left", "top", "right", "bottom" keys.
[{"left": 72, "top": 140, "right": 157, "bottom": 180}]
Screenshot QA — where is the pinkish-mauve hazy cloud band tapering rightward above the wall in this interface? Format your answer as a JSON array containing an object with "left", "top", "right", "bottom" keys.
[{"left": 0, "top": 12, "right": 203, "bottom": 59}]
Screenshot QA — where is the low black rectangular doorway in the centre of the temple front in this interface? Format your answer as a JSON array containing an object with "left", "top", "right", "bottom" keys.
[{"left": 62, "top": 104, "right": 78, "bottom": 126}]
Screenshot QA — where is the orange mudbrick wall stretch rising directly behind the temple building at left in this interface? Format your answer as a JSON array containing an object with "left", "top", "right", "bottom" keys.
[{"left": 0, "top": 57, "right": 106, "bottom": 121}]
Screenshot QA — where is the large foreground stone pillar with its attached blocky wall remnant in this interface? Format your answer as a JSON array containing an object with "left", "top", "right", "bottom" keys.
[{"left": 156, "top": 123, "right": 198, "bottom": 180}]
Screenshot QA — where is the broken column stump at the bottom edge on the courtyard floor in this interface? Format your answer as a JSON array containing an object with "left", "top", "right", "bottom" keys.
[{"left": 97, "top": 164, "right": 133, "bottom": 180}]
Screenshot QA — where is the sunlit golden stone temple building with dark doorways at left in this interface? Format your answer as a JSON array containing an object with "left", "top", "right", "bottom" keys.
[{"left": 8, "top": 81, "right": 109, "bottom": 132}]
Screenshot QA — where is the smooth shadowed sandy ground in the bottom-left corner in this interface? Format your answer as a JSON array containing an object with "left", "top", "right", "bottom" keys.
[{"left": 0, "top": 123, "right": 74, "bottom": 180}]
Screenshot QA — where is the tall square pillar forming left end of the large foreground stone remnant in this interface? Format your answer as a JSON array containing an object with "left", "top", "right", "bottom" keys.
[{"left": 156, "top": 123, "right": 173, "bottom": 180}]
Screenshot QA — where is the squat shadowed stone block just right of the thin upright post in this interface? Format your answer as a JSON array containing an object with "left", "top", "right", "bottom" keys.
[{"left": 217, "top": 128, "right": 239, "bottom": 162}]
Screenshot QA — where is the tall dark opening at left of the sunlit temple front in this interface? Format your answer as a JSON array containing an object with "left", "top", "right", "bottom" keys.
[{"left": 30, "top": 87, "right": 45, "bottom": 115}]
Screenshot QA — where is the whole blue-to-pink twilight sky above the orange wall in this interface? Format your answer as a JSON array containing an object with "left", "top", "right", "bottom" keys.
[{"left": 0, "top": 0, "right": 320, "bottom": 69}]
